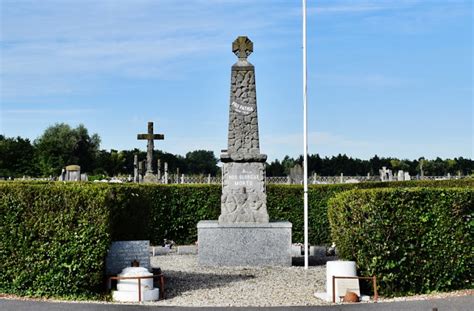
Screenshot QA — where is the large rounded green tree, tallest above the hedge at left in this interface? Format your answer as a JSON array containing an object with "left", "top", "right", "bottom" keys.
[{"left": 34, "top": 123, "right": 100, "bottom": 176}]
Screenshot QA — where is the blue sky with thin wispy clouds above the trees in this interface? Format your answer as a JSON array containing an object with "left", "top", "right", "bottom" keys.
[{"left": 0, "top": 0, "right": 474, "bottom": 159}]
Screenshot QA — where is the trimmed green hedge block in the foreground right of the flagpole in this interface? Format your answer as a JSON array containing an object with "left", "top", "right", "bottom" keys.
[{"left": 329, "top": 188, "right": 474, "bottom": 296}]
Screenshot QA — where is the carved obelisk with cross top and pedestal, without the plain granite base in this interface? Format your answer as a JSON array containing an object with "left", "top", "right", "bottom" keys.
[{"left": 219, "top": 37, "right": 268, "bottom": 224}]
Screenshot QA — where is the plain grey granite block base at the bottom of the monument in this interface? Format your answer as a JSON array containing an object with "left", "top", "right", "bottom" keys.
[{"left": 197, "top": 220, "right": 292, "bottom": 266}]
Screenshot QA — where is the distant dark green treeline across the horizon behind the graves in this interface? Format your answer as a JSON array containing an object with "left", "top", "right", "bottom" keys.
[{"left": 0, "top": 123, "right": 474, "bottom": 178}]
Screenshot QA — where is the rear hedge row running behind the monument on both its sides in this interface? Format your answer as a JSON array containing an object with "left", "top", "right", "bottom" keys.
[{"left": 106, "top": 180, "right": 474, "bottom": 245}]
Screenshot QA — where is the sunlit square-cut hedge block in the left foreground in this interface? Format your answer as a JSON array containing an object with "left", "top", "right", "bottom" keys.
[{"left": 0, "top": 183, "right": 110, "bottom": 297}]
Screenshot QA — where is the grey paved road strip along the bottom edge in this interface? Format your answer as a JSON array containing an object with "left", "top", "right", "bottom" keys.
[{"left": 0, "top": 296, "right": 474, "bottom": 311}]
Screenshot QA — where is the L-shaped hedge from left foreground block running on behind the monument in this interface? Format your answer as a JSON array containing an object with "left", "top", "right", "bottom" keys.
[{"left": 0, "top": 180, "right": 474, "bottom": 298}]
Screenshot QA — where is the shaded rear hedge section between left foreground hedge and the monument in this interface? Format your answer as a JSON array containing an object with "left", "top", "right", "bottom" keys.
[{"left": 106, "top": 184, "right": 221, "bottom": 245}]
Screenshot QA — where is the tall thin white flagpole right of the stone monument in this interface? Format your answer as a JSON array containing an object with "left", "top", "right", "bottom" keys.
[{"left": 302, "top": 0, "right": 309, "bottom": 269}]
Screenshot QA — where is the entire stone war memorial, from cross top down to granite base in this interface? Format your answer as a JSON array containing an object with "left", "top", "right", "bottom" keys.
[{"left": 197, "top": 37, "right": 292, "bottom": 266}]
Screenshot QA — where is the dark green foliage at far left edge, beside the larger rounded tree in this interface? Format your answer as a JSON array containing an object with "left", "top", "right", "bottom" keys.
[{"left": 0, "top": 135, "right": 36, "bottom": 178}]
